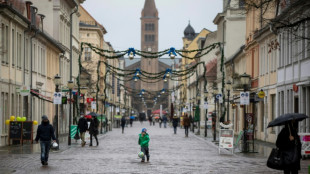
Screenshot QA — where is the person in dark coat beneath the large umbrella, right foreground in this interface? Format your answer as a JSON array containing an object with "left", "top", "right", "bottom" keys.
[{"left": 276, "top": 120, "right": 301, "bottom": 174}]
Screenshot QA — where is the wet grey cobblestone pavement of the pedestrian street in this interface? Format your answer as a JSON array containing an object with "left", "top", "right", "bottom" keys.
[{"left": 0, "top": 122, "right": 307, "bottom": 174}]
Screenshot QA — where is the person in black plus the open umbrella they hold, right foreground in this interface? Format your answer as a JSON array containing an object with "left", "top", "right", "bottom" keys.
[{"left": 267, "top": 113, "right": 308, "bottom": 174}]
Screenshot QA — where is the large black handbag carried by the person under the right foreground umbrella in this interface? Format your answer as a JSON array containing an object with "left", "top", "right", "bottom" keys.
[{"left": 267, "top": 148, "right": 284, "bottom": 170}]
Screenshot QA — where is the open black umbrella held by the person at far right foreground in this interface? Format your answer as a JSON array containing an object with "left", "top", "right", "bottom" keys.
[{"left": 267, "top": 113, "right": 308, "bottom": 128}]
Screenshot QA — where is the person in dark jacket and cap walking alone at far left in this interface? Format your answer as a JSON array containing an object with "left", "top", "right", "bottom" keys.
[{"left": 35, "top": 115, "right": 56, "bottom": 165}]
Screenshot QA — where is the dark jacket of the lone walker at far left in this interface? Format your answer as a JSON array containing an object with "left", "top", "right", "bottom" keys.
[{"left": 35, "top": 121, "right": 56, "bottom": 141}]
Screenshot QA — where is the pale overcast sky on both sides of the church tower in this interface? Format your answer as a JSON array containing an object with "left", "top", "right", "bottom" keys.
[{"left": 82, "top": 0, "right": 223, "bottom": 51}]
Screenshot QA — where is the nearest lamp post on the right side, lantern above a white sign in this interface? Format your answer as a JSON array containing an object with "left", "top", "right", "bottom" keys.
[{"left": 240, "top": 73, "right": 251, "bottom": 152}]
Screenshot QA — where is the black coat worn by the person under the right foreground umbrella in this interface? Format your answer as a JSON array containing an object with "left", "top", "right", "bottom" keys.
[{"left": 276, "top": 125, "right": 301, "bottom": 170}]
